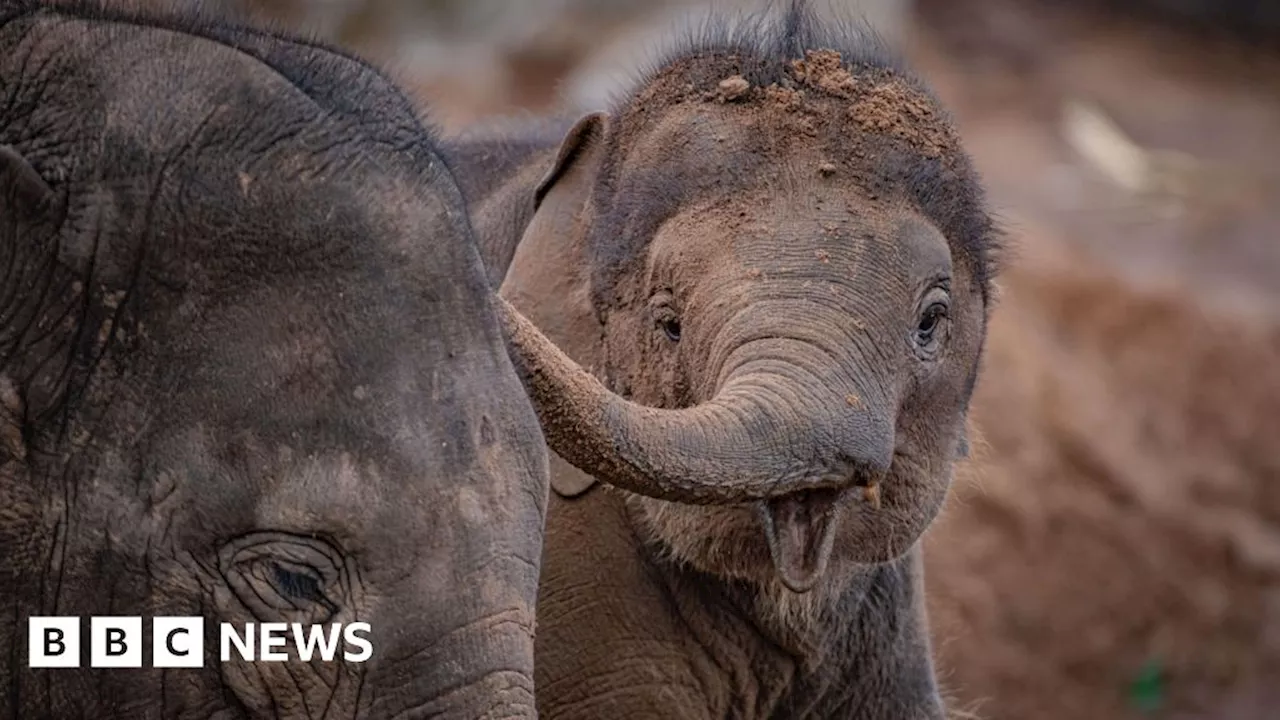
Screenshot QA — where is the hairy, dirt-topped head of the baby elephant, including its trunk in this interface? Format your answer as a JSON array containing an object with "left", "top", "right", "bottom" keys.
[{"left": 507, "top": 23, "right": 998, "bottom": 591}]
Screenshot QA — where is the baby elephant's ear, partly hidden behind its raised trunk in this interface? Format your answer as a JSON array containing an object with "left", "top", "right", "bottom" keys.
[{"left": 502, "top": 113, "right": 609, "bottom": 498}]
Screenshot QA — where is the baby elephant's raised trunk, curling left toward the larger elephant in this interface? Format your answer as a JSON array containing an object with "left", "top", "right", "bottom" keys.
[{"left": 498, "top": 297, "right": 851, "bottom": 505}]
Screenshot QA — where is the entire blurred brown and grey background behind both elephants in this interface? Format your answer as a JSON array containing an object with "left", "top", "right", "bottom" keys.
[{"left": 192, "top": 0, "right": 1280, "bottom": 720}]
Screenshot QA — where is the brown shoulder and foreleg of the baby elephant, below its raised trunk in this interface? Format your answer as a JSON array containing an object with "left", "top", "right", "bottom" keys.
[{"left": 534, "top": 486, "right": 727, "bottom": 720}]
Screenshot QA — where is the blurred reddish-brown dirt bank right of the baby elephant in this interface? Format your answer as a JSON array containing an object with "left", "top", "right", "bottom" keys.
[{"left": 927, "top": 242, "right": 1280, "bottom": 720}]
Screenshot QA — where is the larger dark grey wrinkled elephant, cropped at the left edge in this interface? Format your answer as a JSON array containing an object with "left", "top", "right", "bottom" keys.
[{"left": 0, "top": 1, "right": 547, "bottom": 720}]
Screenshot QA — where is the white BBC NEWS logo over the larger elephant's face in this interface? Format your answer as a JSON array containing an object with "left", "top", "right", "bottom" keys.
[{"left": 27, "top": 618, "right": 374, "bottom": 667}]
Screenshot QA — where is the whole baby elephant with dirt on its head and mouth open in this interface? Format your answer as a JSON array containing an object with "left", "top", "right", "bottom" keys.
[{"left": 445, "top": 4, "right": 997, "bottom": 719}]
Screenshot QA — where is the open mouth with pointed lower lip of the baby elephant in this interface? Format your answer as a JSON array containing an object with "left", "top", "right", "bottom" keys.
[{"left": 759, "top": 491, "right": 844, "bottom": 592}]
